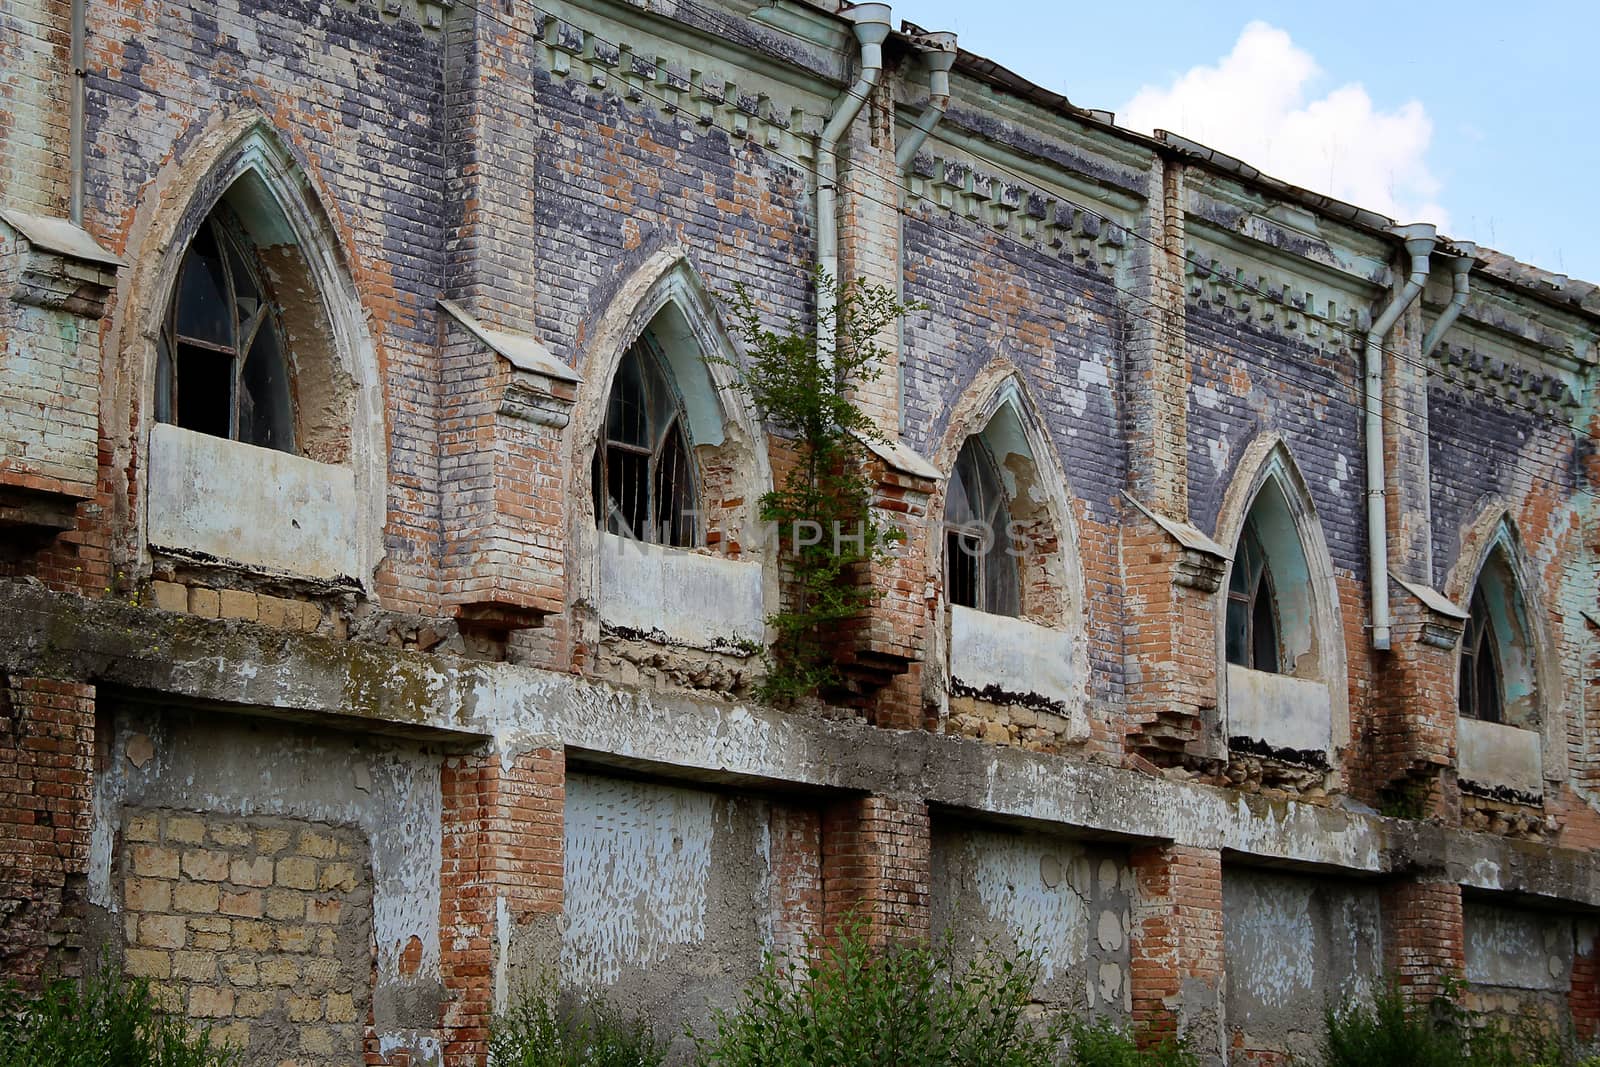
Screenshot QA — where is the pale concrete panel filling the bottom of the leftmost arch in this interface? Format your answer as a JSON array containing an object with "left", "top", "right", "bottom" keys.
[{"left": 147, "top": 422, "right": 362, "bottom": 581}]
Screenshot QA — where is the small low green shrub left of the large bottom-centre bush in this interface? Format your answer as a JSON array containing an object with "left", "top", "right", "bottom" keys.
[{"left": 490, "top": 984, "right": 666, "bottom": 1067}]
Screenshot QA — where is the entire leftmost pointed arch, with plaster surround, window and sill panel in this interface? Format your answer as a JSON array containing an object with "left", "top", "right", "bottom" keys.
[{"left": 123, "top": 118, "right": 386, "bottom": 585}]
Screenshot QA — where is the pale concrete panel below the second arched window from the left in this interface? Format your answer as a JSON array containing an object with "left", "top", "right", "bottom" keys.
[{"left": 600, "top": 531, "right": 766, "bottom": 651}]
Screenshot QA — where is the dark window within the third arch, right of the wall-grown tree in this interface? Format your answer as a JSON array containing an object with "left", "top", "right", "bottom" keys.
[{"left": 944, "top": 437, "right": 1021, "bottom": 616}]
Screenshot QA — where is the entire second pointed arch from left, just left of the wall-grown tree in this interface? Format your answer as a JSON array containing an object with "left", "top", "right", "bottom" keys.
[{"left": 568, "top": 250, "right": 776, "bottom": 669}]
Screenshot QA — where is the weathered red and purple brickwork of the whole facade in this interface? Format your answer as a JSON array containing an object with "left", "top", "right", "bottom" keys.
[{"left": 0, "top": 0, "right": 1600, "bottom": 1064}]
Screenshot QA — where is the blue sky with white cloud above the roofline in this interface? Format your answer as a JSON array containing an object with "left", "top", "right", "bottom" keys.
[{"left": 894, "top": 0, "right": 1600, "bottom": 282}]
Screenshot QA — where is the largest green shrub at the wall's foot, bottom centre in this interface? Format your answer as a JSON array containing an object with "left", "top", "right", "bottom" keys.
[{"left": 698, "top": 925, "right": 1061, "bottom": 1067}]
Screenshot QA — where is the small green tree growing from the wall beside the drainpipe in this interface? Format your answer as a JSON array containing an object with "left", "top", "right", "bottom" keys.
[{"left": 707, "top": 274, "right": 920, "bottom": 702}]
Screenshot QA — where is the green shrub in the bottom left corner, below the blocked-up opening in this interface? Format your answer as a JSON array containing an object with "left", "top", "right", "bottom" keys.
[{"left": 0, "top": 971, "right": 238, "bottom": 1067}]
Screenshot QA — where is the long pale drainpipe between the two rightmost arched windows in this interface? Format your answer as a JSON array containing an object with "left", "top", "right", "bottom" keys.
[{"left": 1366, "top": 222, "right": 1438, "bottom": 651}]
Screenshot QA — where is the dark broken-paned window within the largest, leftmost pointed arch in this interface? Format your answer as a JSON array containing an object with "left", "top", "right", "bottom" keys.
[{"left": 155, "top": 205, "right": 296, "bottom": 453}]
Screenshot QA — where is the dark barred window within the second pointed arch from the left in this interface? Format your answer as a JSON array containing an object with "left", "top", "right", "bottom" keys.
[{"left": 592, "top": 330, "right": 699, "bottom": 547}]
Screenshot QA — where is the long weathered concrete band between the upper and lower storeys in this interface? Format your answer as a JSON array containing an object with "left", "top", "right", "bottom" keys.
[{"left": 18, "top": 582, "right": 1600, "bottom": 907}]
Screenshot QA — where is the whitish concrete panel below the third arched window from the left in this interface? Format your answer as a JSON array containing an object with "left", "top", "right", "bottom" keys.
[{"left": 950, "top": 605, "right": 1082, "bottom": 726}]
